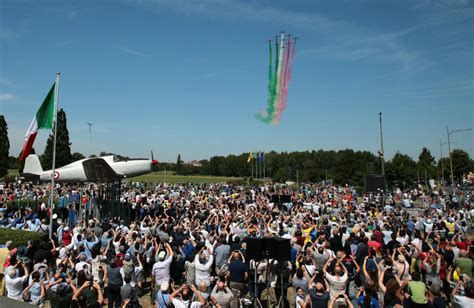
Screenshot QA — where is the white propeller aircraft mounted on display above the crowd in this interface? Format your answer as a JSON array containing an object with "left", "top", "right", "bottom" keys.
[{"left": 21, "top": 152, "right": 158, "bottom": 182}]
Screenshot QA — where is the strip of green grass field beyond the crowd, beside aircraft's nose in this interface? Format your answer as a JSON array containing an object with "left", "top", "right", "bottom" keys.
[{"left": 128, "top": 171, "right": 243, "bottom": 184}]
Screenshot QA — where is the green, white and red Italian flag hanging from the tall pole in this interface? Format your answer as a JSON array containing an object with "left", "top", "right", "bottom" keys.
[{"left": 20, "top": 82, "right": 56, "bottom": 160}]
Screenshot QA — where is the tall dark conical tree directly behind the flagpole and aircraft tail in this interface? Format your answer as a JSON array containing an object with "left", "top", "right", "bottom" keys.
[{"left": 42, "top": 108, "right": 72, "bottom": 169}]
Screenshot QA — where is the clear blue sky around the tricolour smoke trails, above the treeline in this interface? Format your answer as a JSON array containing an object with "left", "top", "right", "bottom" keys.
[{"left": 0, "top": 0, "right": 474, "bottom": 161}]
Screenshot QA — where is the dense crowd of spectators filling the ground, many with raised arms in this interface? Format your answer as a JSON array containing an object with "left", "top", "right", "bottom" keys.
[{"left": 0, "top": 183, "right": 474, "bottom": 308}]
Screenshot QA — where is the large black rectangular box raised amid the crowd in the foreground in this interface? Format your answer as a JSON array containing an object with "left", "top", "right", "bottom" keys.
[{"left": 246, "top": 237, "right": 291, "bottom": 262}]
